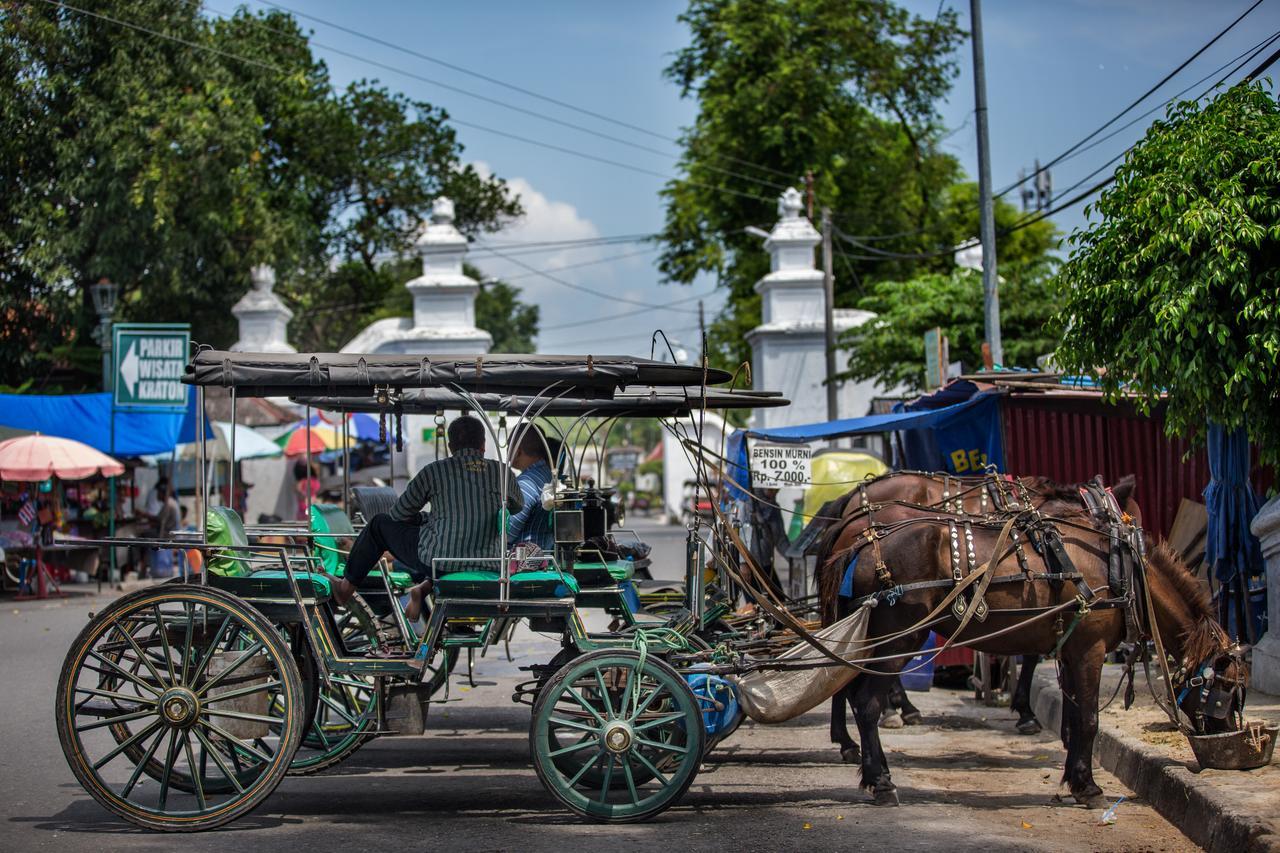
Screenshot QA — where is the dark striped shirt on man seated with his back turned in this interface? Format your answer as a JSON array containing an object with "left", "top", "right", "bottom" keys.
[{"left": 390, "top": 450, "right": 524, "bottom": 575}]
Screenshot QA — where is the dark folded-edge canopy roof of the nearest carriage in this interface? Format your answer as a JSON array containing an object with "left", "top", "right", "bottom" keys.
[{"left": 182, "top": 350, "right": 732, "bottom": 397}]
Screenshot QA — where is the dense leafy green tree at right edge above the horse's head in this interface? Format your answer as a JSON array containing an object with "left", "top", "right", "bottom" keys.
[{"left": 1056, "top": 83, "right": 1280, "bottom": 465}]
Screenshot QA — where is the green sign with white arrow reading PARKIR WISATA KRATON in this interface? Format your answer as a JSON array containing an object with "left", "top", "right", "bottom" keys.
[{"left": 111, "top": 323, "right": 191, "bottom": 411}]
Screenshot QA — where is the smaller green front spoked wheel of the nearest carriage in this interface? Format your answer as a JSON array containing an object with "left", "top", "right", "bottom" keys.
[{"left": 530, "top": 651, "right": 705, "bottom": 824}]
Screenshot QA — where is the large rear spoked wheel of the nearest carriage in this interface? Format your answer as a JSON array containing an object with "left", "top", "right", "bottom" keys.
[{"left": 56, "top": 584, "right": 306, "bottom": 831}]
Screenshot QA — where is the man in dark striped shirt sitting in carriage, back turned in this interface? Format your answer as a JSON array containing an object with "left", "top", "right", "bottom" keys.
[{"left": 333, "top": 415, "right": 524, "bottom": 621}]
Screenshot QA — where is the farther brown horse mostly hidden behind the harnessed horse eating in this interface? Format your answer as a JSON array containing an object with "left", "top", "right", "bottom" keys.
[{"left": 818, "top": 471, "right": 1142, "bottom": 763}]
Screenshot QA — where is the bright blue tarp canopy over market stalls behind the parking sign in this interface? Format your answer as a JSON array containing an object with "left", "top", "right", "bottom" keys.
[{"left": 0, "top": 388, "right": 214, "bottom": 456}]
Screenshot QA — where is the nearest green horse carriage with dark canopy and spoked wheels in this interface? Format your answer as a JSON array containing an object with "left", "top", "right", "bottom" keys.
[{"left": 56, "top": 351, "right": 786, "bottom": 831}]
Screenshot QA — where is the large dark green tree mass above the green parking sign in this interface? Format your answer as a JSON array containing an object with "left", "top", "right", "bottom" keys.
[{"left": 0, "top": 0, "right": 521, "bottom": 384}]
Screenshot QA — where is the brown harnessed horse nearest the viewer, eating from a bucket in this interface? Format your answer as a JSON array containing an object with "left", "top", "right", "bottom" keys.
[{"left": 819, "top": 491, "right": 1248, "bottom": 806}]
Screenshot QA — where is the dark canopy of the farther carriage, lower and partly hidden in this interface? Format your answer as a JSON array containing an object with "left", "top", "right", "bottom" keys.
[{"left": 289, "top": 387, "right": 791, "bottom": 418}]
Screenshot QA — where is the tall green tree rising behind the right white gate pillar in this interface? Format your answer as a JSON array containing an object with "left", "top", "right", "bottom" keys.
[{"left": 660, "top": 0, "right": 963, "bottom": 362}]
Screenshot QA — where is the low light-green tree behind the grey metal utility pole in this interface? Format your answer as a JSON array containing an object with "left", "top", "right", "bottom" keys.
[{"left": 840, "top": 260, "right": 1055, "bottom": 391}]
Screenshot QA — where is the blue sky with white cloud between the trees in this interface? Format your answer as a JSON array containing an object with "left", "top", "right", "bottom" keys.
[{"left": 232, "top": 0, "right": 1280, "bottom": 355}]
